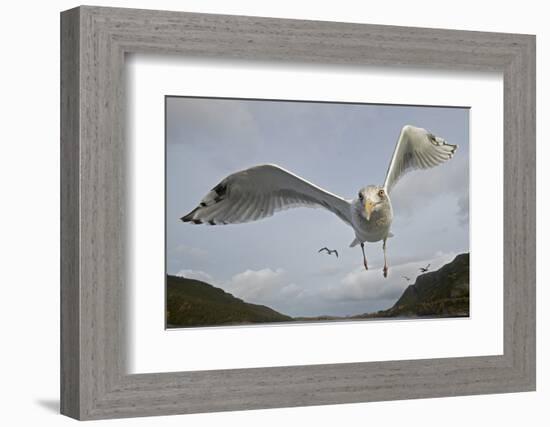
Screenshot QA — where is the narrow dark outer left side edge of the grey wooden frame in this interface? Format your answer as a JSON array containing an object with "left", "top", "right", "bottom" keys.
[{"left": 60, "top": 10, "right": 80, "bottom": 417}]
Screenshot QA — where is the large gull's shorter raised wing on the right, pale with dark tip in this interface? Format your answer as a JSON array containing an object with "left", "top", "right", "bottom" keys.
[{"left": 384, "top": 125, "right": 458, "bottom": 193}]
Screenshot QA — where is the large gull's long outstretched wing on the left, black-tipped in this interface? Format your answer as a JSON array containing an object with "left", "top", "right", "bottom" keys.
[{"left": 181, "top": 165, "right": 351, "bottom": 225}]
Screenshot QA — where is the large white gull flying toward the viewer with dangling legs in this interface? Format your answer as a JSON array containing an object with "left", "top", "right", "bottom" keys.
[{"left": 180, "top": 125, "right": 458, "bottom": 277}]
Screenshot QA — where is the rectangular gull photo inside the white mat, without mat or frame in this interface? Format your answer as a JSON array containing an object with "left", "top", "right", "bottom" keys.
[{"left": 165, "top": 95, "right": 470, "bottom": 329}]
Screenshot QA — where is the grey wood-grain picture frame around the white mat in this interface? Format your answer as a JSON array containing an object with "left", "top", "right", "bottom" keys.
[{"left": 61, "top": 6, "right": 535, "bottom": 419}]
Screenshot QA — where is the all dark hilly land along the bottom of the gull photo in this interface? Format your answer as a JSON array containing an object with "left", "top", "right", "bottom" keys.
[{"left": 166, "top": 254, "right": 470, "bottom": 328}]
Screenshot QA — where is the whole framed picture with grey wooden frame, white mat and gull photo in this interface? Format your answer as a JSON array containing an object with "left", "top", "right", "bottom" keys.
[{"left": 61, "top": 6, "right": 536, "bottom": 420}]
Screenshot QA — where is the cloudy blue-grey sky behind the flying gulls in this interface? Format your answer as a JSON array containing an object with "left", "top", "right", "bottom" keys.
[{"left": 166, "top": 97, "right": 469, "bottom": 316}]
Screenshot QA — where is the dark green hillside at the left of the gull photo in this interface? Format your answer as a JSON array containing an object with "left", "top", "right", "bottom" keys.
[{"left": 166, "top": 276, "right": 292, "bottom": 328}]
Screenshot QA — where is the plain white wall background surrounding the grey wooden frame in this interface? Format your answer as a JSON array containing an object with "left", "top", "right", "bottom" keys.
[{"left": 0, "top": 0, "right": 550, "bottom": 427}]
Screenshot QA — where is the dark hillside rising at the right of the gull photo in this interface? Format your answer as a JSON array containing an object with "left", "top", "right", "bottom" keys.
[{"left": 360, "top": 253, "right": 470, "bottom": 318}]
